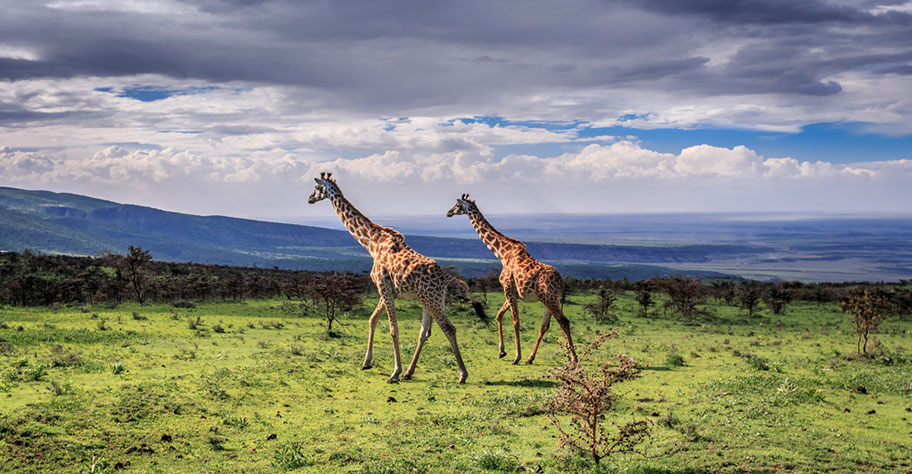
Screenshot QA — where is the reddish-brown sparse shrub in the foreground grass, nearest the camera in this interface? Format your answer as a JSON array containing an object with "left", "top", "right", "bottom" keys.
[{"left": 548, "top": 329, "right": 651, "bottom": 464}]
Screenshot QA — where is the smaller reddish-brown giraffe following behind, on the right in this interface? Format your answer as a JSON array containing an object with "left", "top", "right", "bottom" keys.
[{"left": 446, "top": 194, "right": 577, "bottom": 364}]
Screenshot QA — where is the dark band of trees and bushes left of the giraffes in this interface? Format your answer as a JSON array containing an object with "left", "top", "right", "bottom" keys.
[{"left": 0, "top": 246, "right": 372, "bottom": 306}]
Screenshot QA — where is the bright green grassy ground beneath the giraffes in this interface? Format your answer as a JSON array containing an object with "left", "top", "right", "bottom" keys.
[{"left": 0, "top": 293, "right": 912, "bottom": 473}]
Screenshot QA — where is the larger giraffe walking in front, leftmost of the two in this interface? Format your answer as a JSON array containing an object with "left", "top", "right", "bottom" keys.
[{"left": 307, "top": 173, "right": 485, "bottom": 384}]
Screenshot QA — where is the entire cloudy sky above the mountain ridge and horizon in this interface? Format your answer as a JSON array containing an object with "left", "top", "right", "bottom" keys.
[{"left": 0, "top": 0, "right": 912, "bottom": 221}]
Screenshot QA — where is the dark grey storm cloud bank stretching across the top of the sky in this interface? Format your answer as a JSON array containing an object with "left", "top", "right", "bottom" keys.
[{"left": 0, "top": 0, "right": 912, "bottom": 113}]
